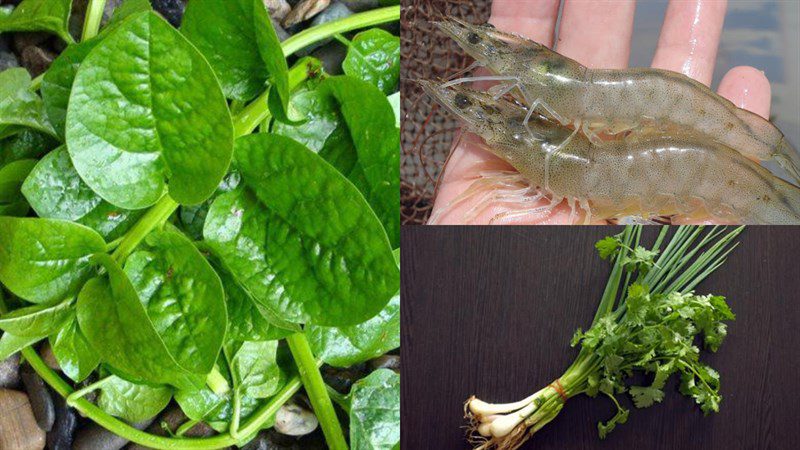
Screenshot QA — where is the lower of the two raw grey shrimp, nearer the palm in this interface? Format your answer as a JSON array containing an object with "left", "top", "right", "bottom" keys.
[{"left": 420, "top": 81, "right": 800, "bottom": 224}]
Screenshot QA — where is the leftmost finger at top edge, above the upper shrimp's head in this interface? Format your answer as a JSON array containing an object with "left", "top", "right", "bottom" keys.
[{"left": 489, "top": 0, "right": 559, "bottom": 47}]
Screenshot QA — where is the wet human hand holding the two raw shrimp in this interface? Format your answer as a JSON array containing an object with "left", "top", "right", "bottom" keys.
[{"left": 433, "top": 0, "right": 770, "bottom": 225}]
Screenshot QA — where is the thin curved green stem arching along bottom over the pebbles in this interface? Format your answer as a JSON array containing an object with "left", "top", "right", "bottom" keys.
[{"left": 22, "top": 347, "right": 303, "bottom": 450}]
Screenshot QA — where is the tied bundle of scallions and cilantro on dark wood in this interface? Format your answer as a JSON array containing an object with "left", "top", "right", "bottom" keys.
[{"left": 465, "top": 226, "right": 742, "bottom": 450}]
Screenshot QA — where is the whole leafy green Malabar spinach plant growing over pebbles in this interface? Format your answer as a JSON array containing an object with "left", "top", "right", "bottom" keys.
[{"left": 0, "top": 0, "right": 400, "bottom": 449}]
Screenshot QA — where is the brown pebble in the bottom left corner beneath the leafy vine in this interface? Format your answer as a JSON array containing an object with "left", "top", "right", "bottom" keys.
[{"left": 0, "top": 389, "right": 45, "bottom": 450}]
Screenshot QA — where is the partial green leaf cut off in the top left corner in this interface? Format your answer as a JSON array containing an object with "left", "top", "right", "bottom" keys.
[{"left": 0, "top": 0, "right": 73, "bottom": 42}]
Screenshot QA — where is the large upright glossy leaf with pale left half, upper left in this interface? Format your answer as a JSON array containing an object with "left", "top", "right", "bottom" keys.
[{"left": 66, "top": 12, "right": 233, "bottom": 209}]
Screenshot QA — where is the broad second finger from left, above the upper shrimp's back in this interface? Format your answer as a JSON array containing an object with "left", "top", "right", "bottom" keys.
[{"left": 558, "top": 0, "right": 636, "bottom": 69}]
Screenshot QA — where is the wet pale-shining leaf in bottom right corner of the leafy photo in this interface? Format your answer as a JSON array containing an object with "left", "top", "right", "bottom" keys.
[{"left": 350, "top": 369, "right": 400, "bottom": 450}]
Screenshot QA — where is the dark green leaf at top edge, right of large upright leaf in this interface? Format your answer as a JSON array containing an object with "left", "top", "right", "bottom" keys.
[{"left": 181, "top": 0, "right": 289, "bottom": 104}]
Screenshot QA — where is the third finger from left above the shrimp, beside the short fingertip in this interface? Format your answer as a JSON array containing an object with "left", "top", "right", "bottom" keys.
[{"left": 652, "top": 0, "right": 727, "bottom": 85}]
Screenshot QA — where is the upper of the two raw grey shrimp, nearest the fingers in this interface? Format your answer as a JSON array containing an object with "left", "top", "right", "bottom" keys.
[{"left": 439, "top": 21, "right": 800, "bottom": 182}]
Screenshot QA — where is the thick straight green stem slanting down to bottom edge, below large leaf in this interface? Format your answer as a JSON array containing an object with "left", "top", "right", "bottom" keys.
[{"left": 286, "top": 333, "right": 347, "bottom": 450}]
